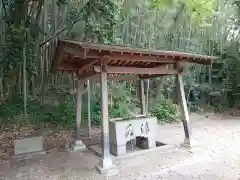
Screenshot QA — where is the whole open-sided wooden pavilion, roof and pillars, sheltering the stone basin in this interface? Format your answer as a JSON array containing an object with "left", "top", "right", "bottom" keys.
[{"left": 52, "top": 40, "right": 215, "bottom": 173}]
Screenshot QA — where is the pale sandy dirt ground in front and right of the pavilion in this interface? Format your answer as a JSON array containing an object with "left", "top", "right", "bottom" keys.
[{"left": 0, "top": 114, "right": 240, "bottom": 180}]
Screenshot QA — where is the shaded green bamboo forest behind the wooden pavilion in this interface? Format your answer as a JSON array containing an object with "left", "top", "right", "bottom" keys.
[{"left": 0, "top": 0, "right": 240, "bottom": 129}]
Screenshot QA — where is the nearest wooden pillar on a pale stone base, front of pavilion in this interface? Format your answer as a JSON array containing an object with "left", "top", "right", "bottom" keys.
[{"left": 96, "top": 67, "right": 118, "bottom": 175}]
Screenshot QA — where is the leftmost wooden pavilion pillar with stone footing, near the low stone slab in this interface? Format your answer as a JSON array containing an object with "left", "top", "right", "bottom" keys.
[{"left": 73, "top": 80, "right": 86, "bottom": 151}]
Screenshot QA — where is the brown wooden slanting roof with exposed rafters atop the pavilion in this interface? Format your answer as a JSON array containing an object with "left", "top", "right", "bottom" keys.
[{"left": 52, "top": 40, "right": 215, "bottom": 78}]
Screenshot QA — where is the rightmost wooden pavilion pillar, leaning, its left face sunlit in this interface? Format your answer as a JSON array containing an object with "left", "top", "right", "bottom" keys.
[{"left": 176, "top": 74, "right": 191, "bottom": 147}]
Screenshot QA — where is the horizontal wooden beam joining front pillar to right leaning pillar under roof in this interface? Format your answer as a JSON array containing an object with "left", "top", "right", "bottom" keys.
[{"left": 93, "top": 66, "right": 177, "bottom": 75}]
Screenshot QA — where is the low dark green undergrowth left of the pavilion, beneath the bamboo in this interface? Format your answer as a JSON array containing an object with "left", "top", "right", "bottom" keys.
[{"left": 0, "top": 96, "right": 76, "bottom": 128}]
